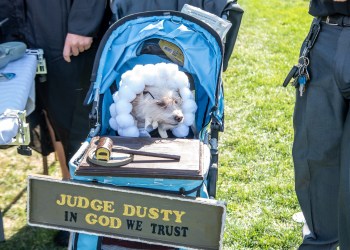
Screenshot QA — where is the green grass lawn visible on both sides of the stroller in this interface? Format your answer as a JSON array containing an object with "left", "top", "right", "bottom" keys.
[{"left": 0, "top": 0, "right": 311, "bottom": 249}]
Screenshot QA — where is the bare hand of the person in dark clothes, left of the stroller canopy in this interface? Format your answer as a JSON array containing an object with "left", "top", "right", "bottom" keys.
[{"left": 63, "top": 33, "right": 92, "bottom": 62}]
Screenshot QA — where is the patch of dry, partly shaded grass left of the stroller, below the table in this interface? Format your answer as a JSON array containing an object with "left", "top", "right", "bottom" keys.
[{"left": 0, "top": 147, "right": 62, "bottom": 250}]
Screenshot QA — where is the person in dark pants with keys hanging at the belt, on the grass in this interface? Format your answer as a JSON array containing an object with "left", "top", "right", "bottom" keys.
[{"left": 293, "top": 0, "right": 350, "bottom": 249}]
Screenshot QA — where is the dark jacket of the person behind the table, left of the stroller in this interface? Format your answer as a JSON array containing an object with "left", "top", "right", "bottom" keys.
[{"left": 0, "top": 0, "right": 106, "bottom": 58}]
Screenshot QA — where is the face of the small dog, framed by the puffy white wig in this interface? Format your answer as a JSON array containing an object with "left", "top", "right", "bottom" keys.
[{"left": 132, "top": 86, "right": 184, "bottom": 130}]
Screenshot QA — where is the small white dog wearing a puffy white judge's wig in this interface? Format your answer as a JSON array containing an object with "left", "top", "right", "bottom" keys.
[{"left": 109, "top": 63, "right": 197, "bottom": 138}]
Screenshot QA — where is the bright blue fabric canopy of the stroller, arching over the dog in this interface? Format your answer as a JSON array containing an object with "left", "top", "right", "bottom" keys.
[{"left": 88, "top": 11, "right": 223, "bottom": 136}]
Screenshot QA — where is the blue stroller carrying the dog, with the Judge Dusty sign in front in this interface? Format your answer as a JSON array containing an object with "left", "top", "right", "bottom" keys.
[{"left": 69, "top": 0, "right": 243, "bottom": 250}]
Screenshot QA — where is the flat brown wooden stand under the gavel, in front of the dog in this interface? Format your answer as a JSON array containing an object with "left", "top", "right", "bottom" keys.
[{"left": 75, "top": 136, "right": 204, "bottom": 180}]
